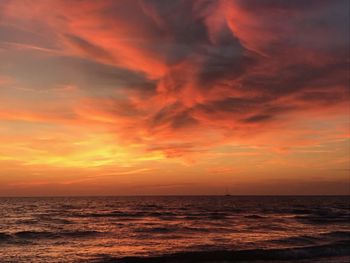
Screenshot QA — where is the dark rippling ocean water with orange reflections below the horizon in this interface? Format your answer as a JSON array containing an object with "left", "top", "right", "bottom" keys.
[{"left": 0, "top": 196, "right": 350, "bottom": 263}]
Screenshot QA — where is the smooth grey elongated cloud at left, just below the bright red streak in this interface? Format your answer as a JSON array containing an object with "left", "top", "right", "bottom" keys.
[{"left": 2, "top": 52, "right": 156, "bottom": 96}]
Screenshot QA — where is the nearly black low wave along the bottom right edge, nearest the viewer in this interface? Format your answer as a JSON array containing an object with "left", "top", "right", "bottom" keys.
[{"left": 93, "top": 241, "right": 350, "bottom": 263}]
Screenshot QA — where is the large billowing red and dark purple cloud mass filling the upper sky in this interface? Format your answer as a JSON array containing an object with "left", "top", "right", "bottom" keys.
[{"left": 2, "top": 0, "right": 349, "bottom": 161}]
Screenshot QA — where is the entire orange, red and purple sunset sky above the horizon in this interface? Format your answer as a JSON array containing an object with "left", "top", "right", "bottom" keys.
[{"left": 0, "top": 0, "right": 350, "bottom": 196}]
